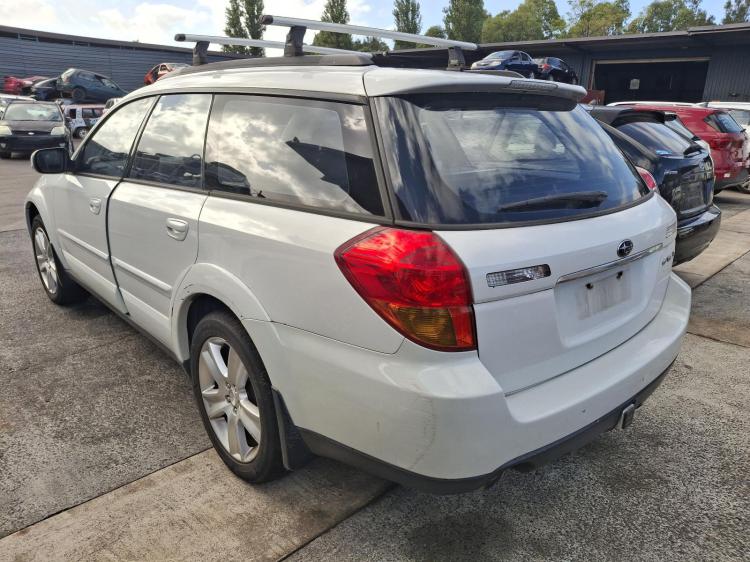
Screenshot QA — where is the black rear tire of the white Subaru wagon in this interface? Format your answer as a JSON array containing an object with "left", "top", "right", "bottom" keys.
[{"left": 190, "top": 311, "right": 284, "bottom": 484}]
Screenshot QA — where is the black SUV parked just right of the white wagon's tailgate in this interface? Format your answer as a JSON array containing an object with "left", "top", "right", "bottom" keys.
[{"left": 591, "top": 107, "right": 721, "bottom": 265}]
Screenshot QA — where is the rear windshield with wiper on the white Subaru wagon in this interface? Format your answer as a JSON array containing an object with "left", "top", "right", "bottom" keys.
[{"left": 375, "top": 93, "right": 648, "bottom": 225}]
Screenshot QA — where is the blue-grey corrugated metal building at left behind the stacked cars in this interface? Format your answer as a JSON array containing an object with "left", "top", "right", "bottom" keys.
[{"left": 0, "top": 25, "right": 237, "bottom": 91}]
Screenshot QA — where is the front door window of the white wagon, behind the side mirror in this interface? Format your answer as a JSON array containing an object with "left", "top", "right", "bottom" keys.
[{"left": 76, "top": 99, "right": 153, "bottom": 178}]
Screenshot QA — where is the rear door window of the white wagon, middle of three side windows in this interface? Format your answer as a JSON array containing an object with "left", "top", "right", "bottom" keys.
[{"left": 130, "top": 94, "right": 211, "bottom": 187}]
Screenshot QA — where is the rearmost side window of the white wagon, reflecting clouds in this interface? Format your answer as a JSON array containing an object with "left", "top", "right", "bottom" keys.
[{"left": 206, "top": 95, "right": 383, "bottom": 215}]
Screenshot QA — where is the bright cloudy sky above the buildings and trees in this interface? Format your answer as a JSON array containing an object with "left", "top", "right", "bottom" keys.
[{"left": 0, "top": 0, "right": 724, "bottom": 49}]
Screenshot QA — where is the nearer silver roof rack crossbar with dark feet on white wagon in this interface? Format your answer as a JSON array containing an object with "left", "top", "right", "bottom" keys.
[{"left": 260, "top": 15, "right": 479, "bottom": 70}]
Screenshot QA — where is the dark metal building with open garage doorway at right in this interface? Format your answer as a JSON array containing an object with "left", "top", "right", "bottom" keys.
[{"left": 410, "top": 23, "right": 750, "bottom": 103}]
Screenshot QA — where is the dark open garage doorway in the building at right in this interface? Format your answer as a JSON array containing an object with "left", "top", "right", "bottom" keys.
[{"left": 593, "top": 58, "right": 709, "bottom": 103}]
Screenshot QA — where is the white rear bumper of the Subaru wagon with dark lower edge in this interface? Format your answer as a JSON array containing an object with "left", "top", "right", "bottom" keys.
[{"left": 258, "top": 275, "right": 690, "bottom": 493}]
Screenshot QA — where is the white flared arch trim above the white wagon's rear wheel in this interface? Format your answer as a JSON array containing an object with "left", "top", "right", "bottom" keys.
[{"left": 171, "top": 263, "right": 271, "bottom": 361}]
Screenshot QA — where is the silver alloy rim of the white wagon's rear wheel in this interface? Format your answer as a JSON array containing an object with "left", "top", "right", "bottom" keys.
[{"left": 198, "top": 337, "right": 261, "bottom": 462}]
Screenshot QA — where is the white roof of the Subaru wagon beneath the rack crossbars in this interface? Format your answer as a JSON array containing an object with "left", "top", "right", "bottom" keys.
[{"left": 138, "top": 62, "right": 586, "bottom": 101}]
